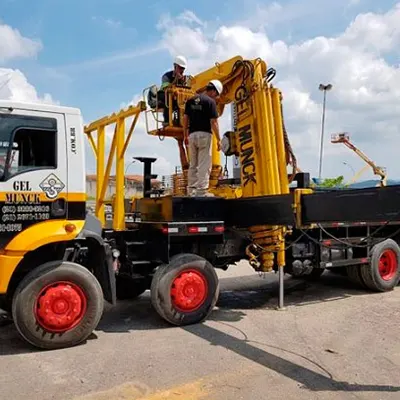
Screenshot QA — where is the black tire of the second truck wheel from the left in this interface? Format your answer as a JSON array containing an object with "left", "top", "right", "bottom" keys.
[{"left": 151, "top": 254, "right": 219, "bottom": 326}]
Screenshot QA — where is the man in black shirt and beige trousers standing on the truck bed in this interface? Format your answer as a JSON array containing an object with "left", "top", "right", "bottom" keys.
[{"left": 183, "top": 79, "right": 223, "bottom": 196}]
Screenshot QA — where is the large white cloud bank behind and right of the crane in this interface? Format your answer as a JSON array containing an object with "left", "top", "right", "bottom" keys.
[{"left": 152, "top": 4, "right": 400, "bottom": 177}]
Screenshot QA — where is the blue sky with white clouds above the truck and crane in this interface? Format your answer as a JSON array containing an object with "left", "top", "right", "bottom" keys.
[{"left": 0, "top": 0, "right": 400, "bottom": 180}]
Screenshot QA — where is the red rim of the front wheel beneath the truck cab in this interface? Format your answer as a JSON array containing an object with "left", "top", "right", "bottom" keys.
[{"left": 35, "top": 282, "right": 87, "bottom": 333}]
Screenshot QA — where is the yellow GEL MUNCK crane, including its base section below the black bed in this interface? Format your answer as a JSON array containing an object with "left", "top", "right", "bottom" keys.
[{"left": 191, "top": 56, "right": 297, "bottom": 271}]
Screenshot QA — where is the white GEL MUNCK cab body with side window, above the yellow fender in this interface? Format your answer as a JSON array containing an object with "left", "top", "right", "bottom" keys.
[{"left": 0, "top": 100, "right": 86, "bottom": 239}]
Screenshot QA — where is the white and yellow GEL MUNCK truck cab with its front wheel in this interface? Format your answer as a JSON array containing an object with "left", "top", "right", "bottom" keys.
[{"left": 0, "top": 100, "right": 111, "bottom": 348}]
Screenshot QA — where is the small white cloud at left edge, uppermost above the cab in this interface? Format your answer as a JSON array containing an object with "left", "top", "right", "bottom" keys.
[{"left": 0, "top": 23, "right": 42, "bottom": 63}]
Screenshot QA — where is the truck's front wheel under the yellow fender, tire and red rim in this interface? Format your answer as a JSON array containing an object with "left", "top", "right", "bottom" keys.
[{"left": 12, "top": 261, "right": 104, "bottom": 349}]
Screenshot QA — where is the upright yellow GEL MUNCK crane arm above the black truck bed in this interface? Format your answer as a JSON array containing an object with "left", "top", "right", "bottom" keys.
[{"left": 191, "top": 56, "right": 297, "bottom": 197}]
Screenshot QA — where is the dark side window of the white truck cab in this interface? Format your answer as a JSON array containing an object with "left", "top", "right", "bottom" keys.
[{"left": 0, "top": 116, "right": 57, "bottom": 180}]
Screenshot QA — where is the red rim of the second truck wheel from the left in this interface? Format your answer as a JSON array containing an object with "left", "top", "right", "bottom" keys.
[{"left": 171, "top": 270, "right": 208, "bottom": 312}]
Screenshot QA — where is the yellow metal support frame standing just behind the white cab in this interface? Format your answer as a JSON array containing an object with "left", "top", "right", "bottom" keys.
[{"left": 84, "top": 101, "right": 146, "bottom": 231}]
